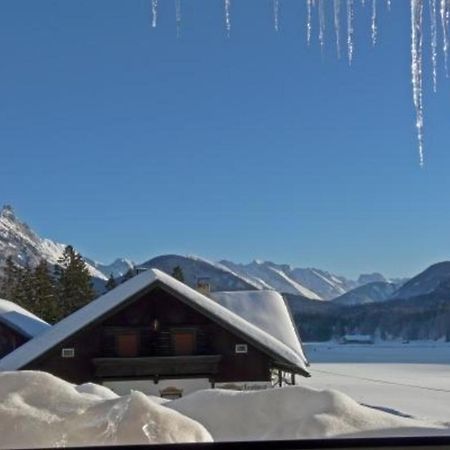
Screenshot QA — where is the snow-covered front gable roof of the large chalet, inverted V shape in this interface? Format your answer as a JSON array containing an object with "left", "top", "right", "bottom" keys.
[{"left": 0, "top": 269, "right": 308, "bottom": 375}]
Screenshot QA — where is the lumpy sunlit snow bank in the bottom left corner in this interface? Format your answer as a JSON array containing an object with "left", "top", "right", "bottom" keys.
[{"left": 0, "top": 372, "right": 211, "bottom": 448}]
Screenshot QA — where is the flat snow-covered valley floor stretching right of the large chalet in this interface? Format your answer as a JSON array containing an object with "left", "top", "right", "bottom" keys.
[{"left": 300, "top": 342, "right": 450, "bottom": 423}]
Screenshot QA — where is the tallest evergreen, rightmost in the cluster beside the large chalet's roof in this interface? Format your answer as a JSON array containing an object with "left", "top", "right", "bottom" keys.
[{"left": 56, "top": 245, "right": 95, "bottom": 319}]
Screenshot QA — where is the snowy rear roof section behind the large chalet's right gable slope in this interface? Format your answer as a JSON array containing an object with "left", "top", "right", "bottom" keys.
[{"left": 211, "top": 290, "right": 306, "bottom": 360}]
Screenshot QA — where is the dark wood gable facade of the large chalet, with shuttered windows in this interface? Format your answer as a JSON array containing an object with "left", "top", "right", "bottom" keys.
[{"left": 23, "top": 285, "right": 272, "bottom": 383}]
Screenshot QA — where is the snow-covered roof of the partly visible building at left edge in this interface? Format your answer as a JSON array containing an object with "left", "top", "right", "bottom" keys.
[{"left": 0, "top": 299, "right": 50, "bottom": 338}]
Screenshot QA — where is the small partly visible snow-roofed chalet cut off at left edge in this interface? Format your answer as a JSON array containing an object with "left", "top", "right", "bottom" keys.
[{"left": 0, "top": 299, "right": 50, "bottom": 358}]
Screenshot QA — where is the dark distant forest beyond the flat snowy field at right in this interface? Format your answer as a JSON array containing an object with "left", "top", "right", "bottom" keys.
[{"left": 285, "top": 280, "right": 450, "bottom": 342}]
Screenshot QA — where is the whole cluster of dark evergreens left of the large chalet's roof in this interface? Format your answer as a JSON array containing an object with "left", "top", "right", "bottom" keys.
[{"left": 0, "top": 245, "right": 97, "bottom": 323}]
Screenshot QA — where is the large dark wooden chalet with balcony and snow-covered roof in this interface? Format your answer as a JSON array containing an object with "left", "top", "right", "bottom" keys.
[{"left": 0, "top": 269, "right": 309, "bottom": 395}]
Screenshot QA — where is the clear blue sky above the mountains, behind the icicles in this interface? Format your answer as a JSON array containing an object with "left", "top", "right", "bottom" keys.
[{"left": 0, "top": 0, "right": 450, "bottom": 276}]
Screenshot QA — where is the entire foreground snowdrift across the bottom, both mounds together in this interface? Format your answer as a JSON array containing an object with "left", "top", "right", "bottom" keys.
[{"left": 0, "top": 372, "right": 449, "bottom": 448}]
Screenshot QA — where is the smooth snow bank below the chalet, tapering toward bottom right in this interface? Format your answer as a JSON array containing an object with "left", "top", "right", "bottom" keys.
[{"left": 167, "top": 386, "right": 448, "bottom": 441}]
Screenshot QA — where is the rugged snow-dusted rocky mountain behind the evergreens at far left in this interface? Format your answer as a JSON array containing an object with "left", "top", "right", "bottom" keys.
[{"left": 0, "top": 205, "right": 118, "bottom": 280}]
